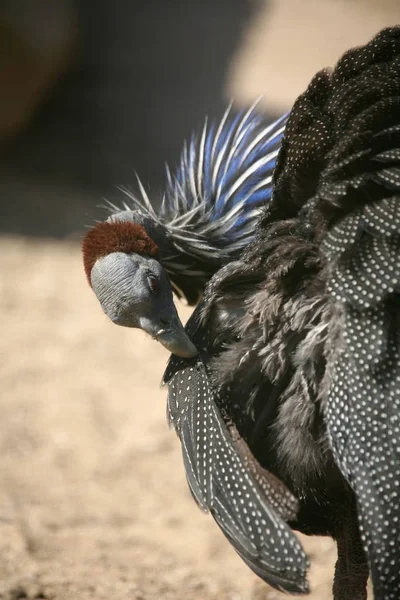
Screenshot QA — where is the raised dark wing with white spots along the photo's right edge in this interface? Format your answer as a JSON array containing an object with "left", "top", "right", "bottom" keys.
[{"left": 319, "top": 28, "right": 400, "bottom": 600}]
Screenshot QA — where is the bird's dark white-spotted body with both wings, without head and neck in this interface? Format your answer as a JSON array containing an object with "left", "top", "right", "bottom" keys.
[{"left": 164, "top": 26, "right": 400, "bottom": 600}]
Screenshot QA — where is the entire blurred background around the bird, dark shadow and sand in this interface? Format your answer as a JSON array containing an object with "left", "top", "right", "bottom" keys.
[{"left": 0, "top": 0, "right": 400, "bottom": 600}]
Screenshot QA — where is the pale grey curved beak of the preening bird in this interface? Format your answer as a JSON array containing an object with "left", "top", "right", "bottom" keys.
[{"left": 140, "top": 307, "right": 197, "bottom": 358}]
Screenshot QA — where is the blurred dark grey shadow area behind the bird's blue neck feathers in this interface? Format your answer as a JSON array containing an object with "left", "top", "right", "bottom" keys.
[{"left": 0, "top": 0, "right": 258, "bottom": 236}]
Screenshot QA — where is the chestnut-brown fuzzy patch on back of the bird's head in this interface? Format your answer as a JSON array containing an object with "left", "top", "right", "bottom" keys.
[{"left": 82, "top": 221, "right": 158, "bottom": 284}]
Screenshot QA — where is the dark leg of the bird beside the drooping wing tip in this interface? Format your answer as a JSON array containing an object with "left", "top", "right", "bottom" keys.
[{"left": 333, "top": 507, "right": 369, "bottom": 600}]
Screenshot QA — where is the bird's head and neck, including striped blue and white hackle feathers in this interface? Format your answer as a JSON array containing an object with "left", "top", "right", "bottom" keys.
[{"left": 82, "top": 101, "right": 287, "bottom": 357}]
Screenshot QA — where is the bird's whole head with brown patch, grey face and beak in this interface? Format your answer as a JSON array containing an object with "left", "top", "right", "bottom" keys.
[{"left": 82, "top": 220, "right": 197, "bottom": 358}]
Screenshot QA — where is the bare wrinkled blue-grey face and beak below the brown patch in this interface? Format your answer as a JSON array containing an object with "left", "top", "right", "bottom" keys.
[{"left": 90, "top": 252, "right": 197, "bottom": 358}]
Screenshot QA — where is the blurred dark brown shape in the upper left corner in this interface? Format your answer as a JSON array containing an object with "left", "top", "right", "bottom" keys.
[{"left": 0, "top": 0, "right": 76, "bottom": 144}]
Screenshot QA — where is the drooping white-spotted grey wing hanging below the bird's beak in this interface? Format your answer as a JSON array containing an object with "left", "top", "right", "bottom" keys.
[{"left": 165, "top": 357, "right": 308, "bottom": 593}]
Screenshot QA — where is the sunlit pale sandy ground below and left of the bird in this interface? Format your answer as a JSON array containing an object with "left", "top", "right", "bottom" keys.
[{"left": 0, "top": 238, "right": 344, "bottom": 600}]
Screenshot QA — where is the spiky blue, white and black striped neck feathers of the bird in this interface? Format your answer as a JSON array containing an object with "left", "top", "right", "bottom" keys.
[{"left": 112, "top": 105, "right": 287, "bottom": 271}]
